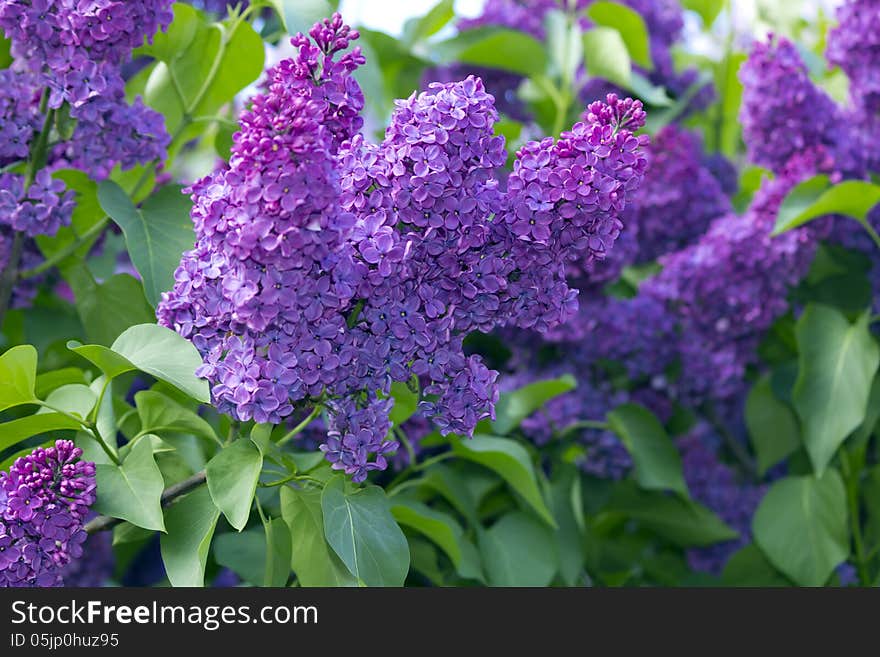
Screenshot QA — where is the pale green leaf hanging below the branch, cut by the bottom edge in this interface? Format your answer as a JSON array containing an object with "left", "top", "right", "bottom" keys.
[{"left": 160, "top": 488, "right": 220, "bottom": 586}]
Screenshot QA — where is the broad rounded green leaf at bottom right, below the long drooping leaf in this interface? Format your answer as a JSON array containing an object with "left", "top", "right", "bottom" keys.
[{"left": 752, "top": 470, "right": 849, "bottom": 586}]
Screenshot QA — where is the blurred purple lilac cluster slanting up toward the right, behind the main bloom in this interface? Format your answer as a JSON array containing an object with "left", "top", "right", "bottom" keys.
[{"left": 641, "top": 149, "right": 833, "bottom": 404}]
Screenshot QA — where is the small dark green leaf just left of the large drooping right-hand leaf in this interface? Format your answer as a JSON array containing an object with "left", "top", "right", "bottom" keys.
[{"left": 745, "top": 374, "right": 801, "bottom": 475}]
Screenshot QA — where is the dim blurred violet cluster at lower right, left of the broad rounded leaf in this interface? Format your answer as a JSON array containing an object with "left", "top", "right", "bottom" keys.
[{"left": 678, "top": 425, "right": 766, "bottom": 575}]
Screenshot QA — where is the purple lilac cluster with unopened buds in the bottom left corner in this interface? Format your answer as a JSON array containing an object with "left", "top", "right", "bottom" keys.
[{"left": 0, "top": 440, "right": 95, "bottom": 587}]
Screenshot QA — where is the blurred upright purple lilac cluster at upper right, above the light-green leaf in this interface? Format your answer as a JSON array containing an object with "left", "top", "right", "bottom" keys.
[{"left": 739, "top": 35, "right": 842, "bottom": 171}]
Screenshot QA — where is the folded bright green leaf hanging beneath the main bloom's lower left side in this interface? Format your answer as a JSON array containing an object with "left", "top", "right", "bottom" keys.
[{"left": 205, "top": 438, "right": 263, "bottom": 531}]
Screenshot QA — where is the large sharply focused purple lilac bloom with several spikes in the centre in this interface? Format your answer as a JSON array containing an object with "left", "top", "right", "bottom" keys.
[{"left": 158, "top": 15, "right": 646, "bottom": 481}]
